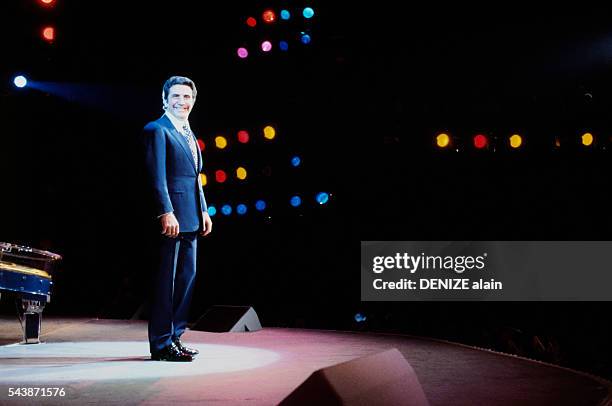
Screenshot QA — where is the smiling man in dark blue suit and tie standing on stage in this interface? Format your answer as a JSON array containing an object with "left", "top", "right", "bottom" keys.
[{"left": 144, "top": 76, "right": 212, "bottom": 361}]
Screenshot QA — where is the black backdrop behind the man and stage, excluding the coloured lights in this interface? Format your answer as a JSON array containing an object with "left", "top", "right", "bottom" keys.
[{"left": 0, "top": 1, "right": 612, "bottom": 377}]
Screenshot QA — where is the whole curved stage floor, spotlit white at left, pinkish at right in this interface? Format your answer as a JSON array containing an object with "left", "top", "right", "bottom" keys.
[{"left": 0, "top": 318, "right": 612, "bottom": 405}]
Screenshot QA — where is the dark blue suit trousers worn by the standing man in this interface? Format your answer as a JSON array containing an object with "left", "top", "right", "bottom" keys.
[{"left": 149, "top": 232, "right": 198, "bottom": 352}]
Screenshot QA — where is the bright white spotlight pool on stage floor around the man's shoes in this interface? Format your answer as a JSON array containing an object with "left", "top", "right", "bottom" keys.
[{"left": 0, "top": 341, "right": 280, "bottom": 383}]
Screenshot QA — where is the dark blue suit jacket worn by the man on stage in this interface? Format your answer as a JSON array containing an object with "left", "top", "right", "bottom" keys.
[{"left": 144, "top": 115, "right": 207, "bottom": 232}]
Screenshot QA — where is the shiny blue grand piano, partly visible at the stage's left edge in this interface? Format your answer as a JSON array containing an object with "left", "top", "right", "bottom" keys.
[{"left": 0, "top": 242, "right": 62, "bottom": 344}]
